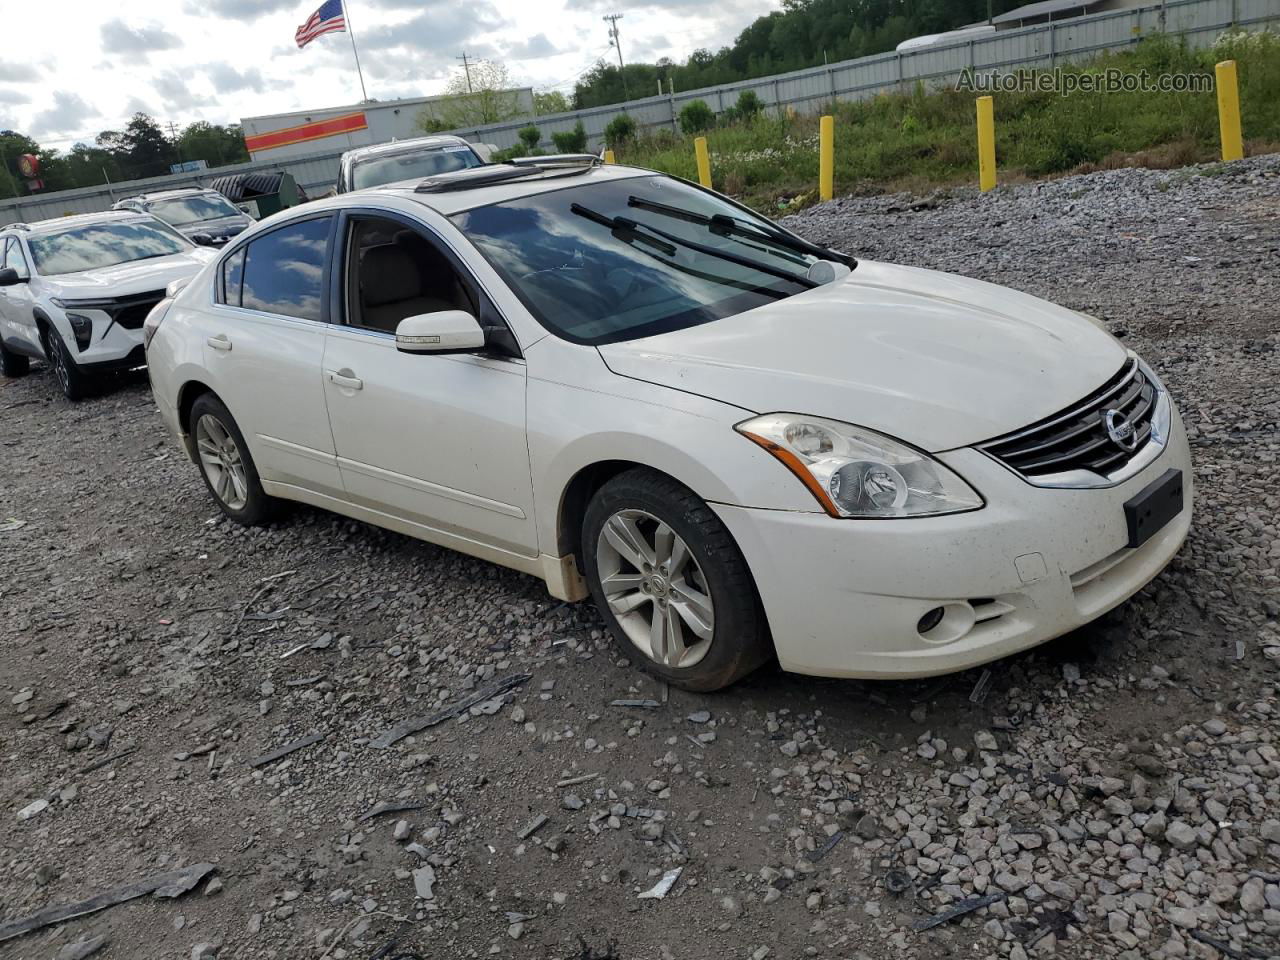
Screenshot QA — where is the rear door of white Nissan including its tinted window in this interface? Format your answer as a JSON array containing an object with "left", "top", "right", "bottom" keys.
[{"left": 200, "top": 214, "right": 342, "bottom": 497}]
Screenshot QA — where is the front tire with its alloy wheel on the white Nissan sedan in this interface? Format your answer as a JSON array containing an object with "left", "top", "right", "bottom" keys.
[{"left": 582, "top": 468, "right": 773, "bottom": 691}]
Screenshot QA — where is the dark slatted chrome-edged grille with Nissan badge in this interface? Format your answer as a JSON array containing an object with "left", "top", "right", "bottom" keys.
[{"left": 979, "top": 360, "right": 1156, "bottom": 479}]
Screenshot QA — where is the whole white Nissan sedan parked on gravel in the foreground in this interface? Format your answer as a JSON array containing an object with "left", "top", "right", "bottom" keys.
[{"left": 146, "top": 157, "right": 1192, "bottom": 690}]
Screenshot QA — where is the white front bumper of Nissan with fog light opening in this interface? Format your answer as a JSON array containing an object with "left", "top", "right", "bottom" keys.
[{"left": 713, "top": 411, "right": 1193, "bottom": 678}]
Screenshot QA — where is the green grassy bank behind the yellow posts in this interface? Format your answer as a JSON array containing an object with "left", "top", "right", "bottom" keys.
[{"left": 614, "top": 32, "right": 1280, "bottom": 210}]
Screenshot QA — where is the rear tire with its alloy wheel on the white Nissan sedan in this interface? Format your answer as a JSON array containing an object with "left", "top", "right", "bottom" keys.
[{"left": 187, "top": 393, "right": 279, "bottom": 526}]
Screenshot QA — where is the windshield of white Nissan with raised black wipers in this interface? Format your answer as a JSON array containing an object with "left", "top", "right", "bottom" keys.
[{"left": 452, "top": 177, "right": 818, "bottom": 344}]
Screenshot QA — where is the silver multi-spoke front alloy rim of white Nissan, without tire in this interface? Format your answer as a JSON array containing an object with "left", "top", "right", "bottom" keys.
[{"left": 595, "top": 509, "right": 716, "bottom": 667}]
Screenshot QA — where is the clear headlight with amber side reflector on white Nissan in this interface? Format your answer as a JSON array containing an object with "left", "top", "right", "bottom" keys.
[{"left": 735, "top": 413, "right": 983, "bottom": 518}]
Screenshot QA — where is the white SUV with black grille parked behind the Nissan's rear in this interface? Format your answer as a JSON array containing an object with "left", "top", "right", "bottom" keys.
[{"left": 0, "top": 211, "right": 215, "bottom": 401}]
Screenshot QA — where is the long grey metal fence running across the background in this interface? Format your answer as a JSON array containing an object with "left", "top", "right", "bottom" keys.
[{"left": 0, "top": 0, "right": 1280, "bottom": 224}]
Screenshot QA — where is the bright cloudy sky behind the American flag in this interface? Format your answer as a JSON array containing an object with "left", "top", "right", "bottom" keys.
[{"left": 0, "top": 0, "right": 777, "bottom": 150}]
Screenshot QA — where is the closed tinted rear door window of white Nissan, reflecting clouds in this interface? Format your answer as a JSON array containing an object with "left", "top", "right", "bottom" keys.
[{"left": 241, "top": 216, "right": 332, "bottom": 320}]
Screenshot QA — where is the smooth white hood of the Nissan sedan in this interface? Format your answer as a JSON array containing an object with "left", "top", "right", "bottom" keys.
[{"left": 599, "top": 260, "right": 1126, "bottom": 452}]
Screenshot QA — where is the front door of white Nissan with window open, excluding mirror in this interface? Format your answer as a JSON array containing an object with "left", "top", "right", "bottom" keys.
[{"left": 324, "top": 209, "right": 538, "bottom": 557}]
